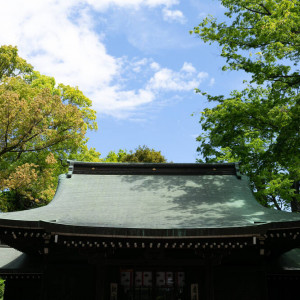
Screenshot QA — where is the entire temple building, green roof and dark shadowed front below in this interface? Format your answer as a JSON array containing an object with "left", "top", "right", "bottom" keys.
[{"left": 0, "top": 161, "right": 300, "bottom": 300}]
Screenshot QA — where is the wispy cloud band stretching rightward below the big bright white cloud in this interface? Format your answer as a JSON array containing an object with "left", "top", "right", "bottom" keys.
[{"left": 91, "top": 60, "right": 208, "bottom": 118}]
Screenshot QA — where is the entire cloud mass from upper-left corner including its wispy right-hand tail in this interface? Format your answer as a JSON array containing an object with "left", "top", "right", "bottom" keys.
[{"left": 0, "top": 0, "right": 207, "bottom": 118}]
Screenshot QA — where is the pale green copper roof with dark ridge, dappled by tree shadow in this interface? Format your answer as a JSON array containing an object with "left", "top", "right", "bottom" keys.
[{"left": 0, "top": 163, "right": 300, "bottom": 234}]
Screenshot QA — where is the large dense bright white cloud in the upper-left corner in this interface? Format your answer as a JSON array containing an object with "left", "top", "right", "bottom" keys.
[{"left": 0, "top": 1, "right": 119, "bottom": 91}]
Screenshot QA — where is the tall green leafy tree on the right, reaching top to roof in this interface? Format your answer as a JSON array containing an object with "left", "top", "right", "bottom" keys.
[{"left": 191, "top": 0, "right": 300, "bottom": 211}]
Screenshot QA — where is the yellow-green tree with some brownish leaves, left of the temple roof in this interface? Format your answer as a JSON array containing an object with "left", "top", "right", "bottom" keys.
[{"left": 0, "top": 46, "right": 100, "bottom": 210}]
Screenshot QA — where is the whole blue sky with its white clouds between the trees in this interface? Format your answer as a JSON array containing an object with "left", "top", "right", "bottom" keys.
[{"left": 0, "top": 0, "right": 244, "bottom": 162}]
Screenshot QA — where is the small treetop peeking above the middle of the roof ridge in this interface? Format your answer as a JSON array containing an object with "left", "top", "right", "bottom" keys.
[{"left": 104, "top": 146, "right": 167, "bottom": 163}]
